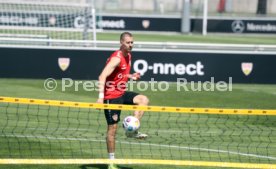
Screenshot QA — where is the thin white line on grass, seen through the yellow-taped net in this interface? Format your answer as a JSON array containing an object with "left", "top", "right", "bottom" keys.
[{"left": 0, "top": 134, "right": 276, "bottom": 160}]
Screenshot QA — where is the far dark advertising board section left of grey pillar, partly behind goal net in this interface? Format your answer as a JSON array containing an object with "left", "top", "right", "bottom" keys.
[{"left": 0, "top": 11, "right": 181, "bottom": 32}]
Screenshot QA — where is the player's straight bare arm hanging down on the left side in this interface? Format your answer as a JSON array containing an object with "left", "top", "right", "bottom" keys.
[{"left": 97, "top": 57, "right": 121, "bottom": 103}]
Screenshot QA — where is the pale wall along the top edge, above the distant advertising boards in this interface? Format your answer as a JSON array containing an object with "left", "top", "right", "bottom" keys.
[{"left": 5, "top": 0, "right": 276, "bottom": 14}]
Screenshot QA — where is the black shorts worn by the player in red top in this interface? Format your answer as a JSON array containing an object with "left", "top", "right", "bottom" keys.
[{"left": 104, "top": 92, "right": 138, "bottom": 125}]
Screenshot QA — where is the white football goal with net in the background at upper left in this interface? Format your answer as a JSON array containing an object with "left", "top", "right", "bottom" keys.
[{"left": 0, "top": 0, "right": 97, "bottom": 47}]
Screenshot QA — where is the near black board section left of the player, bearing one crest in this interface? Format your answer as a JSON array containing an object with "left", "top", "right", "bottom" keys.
[{"left": 0, "top": 48, "right": 110, "bottom": 79}]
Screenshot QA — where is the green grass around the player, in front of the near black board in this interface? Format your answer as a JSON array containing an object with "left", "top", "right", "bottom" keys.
[{"left": 0, "top": 79, "right": 276, "bottom": 169}]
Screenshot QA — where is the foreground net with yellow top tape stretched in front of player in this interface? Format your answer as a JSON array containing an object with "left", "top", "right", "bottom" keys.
[{"left": 0, "top": 97, "right": 276, "bottom": 168}]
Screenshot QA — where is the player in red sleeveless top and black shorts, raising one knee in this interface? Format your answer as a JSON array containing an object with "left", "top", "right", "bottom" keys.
[{"left": 97, "top": 32, "right": 149, "bottom": 169}]
